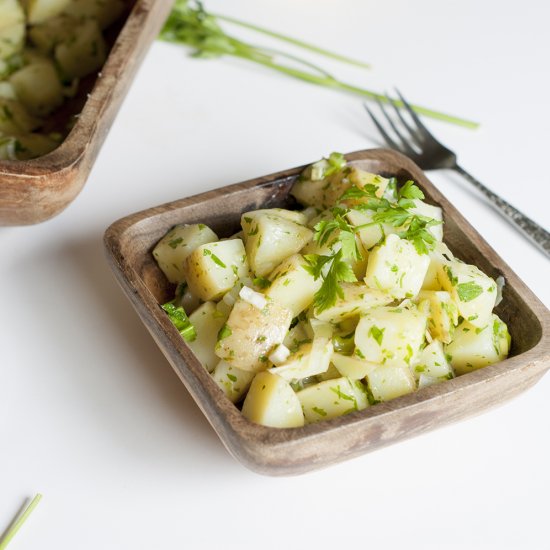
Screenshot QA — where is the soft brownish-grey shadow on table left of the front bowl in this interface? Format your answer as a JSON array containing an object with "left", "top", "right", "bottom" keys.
[{"left": 18, "top": 231, "right": 247, "bottom": 476}]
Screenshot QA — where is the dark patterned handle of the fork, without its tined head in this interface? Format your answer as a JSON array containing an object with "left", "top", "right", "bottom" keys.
[{"left": 453, "top": 164, "right": 550, "bottom": 258}]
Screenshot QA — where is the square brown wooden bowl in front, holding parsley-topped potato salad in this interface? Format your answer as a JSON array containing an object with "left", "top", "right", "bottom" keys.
[{"left": 105, "top": 150, "right": 550, "bottom": 475}]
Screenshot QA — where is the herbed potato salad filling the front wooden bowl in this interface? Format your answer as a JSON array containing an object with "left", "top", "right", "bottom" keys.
[{"left": 153, "top": 153, "right": 510, "bottom": 428}]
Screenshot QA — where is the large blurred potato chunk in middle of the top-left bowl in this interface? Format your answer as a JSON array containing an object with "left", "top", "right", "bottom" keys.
[{"left": 10, "top": 58, "right": 65, "bottom": 117}]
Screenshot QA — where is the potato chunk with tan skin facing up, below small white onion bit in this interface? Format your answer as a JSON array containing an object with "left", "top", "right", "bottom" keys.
[{"left": 216, "top": 299, "right": 292, "bottom": 372}]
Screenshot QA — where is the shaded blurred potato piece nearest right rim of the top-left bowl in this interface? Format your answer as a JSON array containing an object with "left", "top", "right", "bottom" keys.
[{"left": 54, "top": 19, "right": 107, "bottom": 79}]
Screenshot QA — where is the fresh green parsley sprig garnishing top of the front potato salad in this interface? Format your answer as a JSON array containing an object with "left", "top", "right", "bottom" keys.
[{"left": 304, "top": 178, "right": 441, "bottom": 313}]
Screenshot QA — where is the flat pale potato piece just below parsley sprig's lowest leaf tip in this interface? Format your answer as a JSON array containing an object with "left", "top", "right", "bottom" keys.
[{"left": 314, "top": 283, "right": 393, "bottom": 323}]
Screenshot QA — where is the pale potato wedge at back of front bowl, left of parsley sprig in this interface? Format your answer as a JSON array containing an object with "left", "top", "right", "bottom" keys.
[{"left": 241, "top": 213, "right": 313, "bottom": 277}]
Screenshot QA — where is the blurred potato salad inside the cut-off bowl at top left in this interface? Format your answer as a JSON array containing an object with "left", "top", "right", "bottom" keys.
[{"left": 0, "top": 0, "right": 125, "bottom": 160}]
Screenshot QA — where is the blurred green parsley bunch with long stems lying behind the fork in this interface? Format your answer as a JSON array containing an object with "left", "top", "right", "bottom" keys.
[{"left": 159, "top": 0, "right": 479, "bottom": 129}]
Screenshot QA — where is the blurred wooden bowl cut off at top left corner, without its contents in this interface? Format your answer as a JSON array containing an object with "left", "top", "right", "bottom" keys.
[{"left": 0, "top": 0, "right": 172, "bottom": 225}]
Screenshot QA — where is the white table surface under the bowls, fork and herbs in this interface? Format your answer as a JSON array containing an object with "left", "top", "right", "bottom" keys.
[{"left": 0, "top": 0, "right": 550, "bottom": 550}]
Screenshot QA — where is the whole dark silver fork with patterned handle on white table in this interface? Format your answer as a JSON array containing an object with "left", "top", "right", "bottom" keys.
[{"left": 364, "top": 92, "right": 550, "bottom": 258}]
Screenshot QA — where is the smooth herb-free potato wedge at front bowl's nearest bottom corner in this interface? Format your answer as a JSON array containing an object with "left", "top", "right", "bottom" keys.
[{"left": 242, "top": 372, "right": 304, "bottom": 428}]
